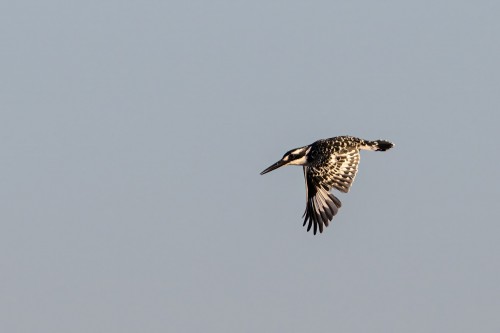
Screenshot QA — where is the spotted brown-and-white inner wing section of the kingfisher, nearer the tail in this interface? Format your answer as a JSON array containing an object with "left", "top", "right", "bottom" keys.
[{"left": 325, "top": 148, "right": 360, "bottom": 193}]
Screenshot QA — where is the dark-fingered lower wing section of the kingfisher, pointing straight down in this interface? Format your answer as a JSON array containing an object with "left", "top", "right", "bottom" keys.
[{"left": 303, "top": 166, "right": 342, "bottom": 235}]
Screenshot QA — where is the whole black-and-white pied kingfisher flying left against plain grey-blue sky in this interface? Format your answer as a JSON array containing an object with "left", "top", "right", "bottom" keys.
[{"left": 260, "top": 135, "right": 394, "bottom": 235}]
